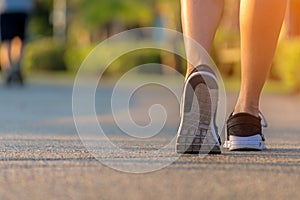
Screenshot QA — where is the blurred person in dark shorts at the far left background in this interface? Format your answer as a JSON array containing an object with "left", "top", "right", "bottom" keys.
[{"left": 0, "top": 0, "right": 34, "bottom": 85}]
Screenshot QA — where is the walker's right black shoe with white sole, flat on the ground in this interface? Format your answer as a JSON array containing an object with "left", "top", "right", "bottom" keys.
[{"left": 224, "top": 113, "right": 267, "bottom": 151}]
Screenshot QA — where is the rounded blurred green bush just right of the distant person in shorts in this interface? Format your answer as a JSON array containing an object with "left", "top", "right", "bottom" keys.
[{"left": 23, "top": 38, "right": 67, "bottom": 71}]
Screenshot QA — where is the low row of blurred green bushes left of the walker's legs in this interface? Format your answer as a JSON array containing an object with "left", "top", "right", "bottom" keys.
[{"left": 23, "top": 38, "right": 161, "bottom": 76}]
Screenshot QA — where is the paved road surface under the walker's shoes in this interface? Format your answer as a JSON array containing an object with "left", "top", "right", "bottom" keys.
[{"left": 0, "top": 77, "right": 300, "bottom": 200}]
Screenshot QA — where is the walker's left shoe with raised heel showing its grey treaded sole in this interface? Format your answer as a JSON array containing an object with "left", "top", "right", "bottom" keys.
[{"left": 176, "top": 65, "right": 221, "bottom": 154}]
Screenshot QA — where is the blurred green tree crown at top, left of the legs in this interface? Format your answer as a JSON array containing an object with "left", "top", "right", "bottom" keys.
[{"left": 70, "top": 0, "right": 153, "bottom": 40}]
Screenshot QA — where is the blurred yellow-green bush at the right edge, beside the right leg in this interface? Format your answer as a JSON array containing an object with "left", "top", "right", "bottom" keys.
[{"left": 273, "top": 38, "right": 300, "bottom": 92}]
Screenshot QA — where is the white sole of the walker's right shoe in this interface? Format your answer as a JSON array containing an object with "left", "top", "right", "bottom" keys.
[{"left": 229, "top": 134, "right": 266, "bottom": 151}]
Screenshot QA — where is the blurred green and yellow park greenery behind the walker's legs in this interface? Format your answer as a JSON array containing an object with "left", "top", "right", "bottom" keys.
[{"left": 0, "top": 0, "right": 300, "bottom": 93}]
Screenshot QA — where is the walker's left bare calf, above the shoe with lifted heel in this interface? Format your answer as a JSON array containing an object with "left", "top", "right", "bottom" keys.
[{"left": 181, "top": 0, "right": 224, "bottom": 74}]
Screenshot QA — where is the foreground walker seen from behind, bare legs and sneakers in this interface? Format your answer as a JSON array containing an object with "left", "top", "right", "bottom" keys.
[{"left": 176, "top": 0, "right": 287, "bottom": 153}]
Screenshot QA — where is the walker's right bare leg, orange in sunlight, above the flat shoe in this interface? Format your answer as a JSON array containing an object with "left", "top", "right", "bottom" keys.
[{"left": 234, "top": 0, "right": 287, "bottom": 116}]
